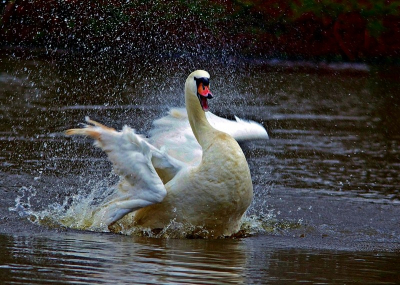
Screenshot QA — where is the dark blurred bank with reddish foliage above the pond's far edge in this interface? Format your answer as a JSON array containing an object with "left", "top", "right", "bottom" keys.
[{"left": 0, "top": 0, "right": 400, "bottom": 63}]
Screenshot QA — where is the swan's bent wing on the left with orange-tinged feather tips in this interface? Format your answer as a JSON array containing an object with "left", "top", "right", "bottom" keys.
[{"left": 66, "top": 118, "right": 172, "bottom": 227}]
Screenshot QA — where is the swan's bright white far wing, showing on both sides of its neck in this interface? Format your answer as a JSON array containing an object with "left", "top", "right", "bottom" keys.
[{"left": 149, "top": 108, "right": 268, "bottom": 165}]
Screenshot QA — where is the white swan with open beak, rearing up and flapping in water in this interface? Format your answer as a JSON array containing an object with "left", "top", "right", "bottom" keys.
[{"left": 66, "top": 70, "right": 268, "bottom": 238}]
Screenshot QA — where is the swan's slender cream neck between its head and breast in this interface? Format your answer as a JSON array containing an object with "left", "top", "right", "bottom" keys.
[{"left": 185, "top": 88, "right": 214, "bottom": 149}]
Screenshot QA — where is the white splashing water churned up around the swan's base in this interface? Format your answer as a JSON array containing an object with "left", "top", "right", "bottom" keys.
[{"left": 9, "top": 179, "right": 302, "bottom": 239}]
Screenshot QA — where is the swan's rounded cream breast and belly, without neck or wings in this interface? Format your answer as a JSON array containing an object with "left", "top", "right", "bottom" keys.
[{"left": 135, "top": 127, "right": 253, "bottom": 238}]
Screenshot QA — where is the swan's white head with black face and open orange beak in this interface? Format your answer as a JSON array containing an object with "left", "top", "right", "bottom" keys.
[{"left": 186, "top": 70, "right": 213, "bottom": 112}]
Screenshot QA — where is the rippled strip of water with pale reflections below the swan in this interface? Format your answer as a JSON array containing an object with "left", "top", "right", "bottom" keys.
[{"left": 0, "top": 233, "right": 400, "bottom": 284}]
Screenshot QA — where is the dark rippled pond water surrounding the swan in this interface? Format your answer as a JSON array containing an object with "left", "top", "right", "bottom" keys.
[{"left": 0, "top": 57, "right": 400, "bottom": 284}]
